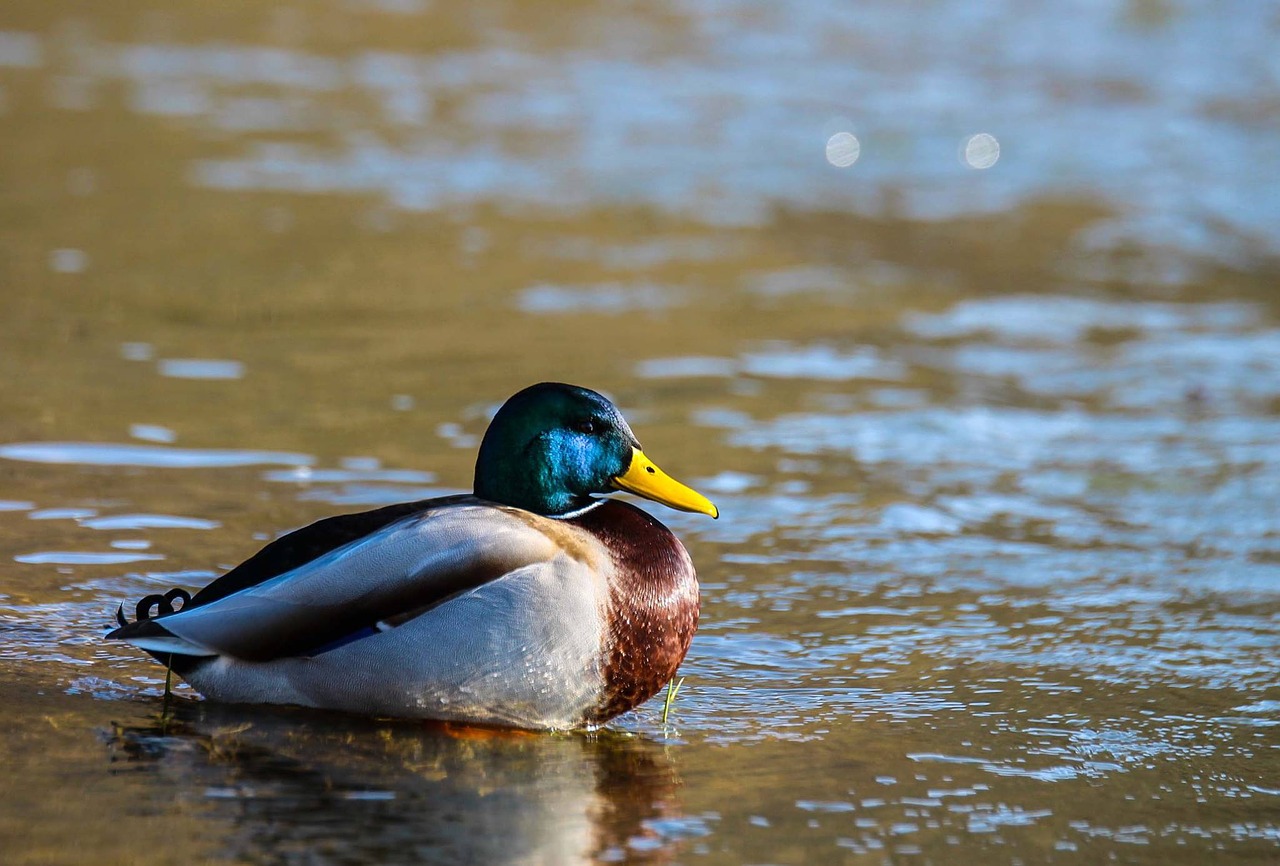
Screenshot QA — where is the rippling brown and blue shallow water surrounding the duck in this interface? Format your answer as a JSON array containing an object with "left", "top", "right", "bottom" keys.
[{"left": 0, "top": 0, "right": 1280, "bottom": 863}]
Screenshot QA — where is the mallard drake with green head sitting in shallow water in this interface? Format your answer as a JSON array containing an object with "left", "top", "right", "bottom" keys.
[{"left": 106, "top": 382, "right": 719, "bottom": 729}]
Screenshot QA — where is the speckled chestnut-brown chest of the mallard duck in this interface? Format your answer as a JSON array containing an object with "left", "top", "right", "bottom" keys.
[{"left": 575, "top": 500, "right": 699, "bottom": 723}]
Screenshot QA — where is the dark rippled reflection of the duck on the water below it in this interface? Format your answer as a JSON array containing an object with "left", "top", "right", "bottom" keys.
[{"left": 108, "top": 701, "right": 680, "bottom": 863}]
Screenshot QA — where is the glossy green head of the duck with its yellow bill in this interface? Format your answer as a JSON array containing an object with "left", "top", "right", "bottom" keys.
[{"left": 475, "top": 382, "right": 718, "bottom": 517}]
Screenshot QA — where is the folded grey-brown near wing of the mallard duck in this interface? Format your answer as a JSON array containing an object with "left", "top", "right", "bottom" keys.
[{"left": 108, "top": 499, "right": 563, "bottom": 661}]
